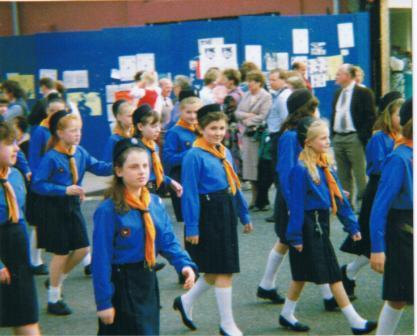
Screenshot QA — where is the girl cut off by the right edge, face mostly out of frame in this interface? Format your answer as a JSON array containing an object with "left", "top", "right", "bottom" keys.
[{"left": 370, "top": 99, "right": 414, "bottom": 335}]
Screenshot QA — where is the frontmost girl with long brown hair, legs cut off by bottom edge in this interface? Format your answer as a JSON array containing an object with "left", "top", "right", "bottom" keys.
[{"left": 92, "top": 138, "right": 196, "bottom": 335}]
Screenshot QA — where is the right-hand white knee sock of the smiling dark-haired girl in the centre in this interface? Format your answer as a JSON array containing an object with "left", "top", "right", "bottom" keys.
[{"left": 215, "top": 287, "right": 243, "bottom": 336}]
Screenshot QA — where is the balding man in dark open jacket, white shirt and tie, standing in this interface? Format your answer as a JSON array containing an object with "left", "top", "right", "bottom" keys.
[{"left": 331, "top": 64, "right": 375, "bottom": 209}]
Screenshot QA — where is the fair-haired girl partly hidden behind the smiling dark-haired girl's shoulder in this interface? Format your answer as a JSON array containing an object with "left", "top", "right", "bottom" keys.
[{"left": 162, "top": 97, "right": 202, "bottom": 222}]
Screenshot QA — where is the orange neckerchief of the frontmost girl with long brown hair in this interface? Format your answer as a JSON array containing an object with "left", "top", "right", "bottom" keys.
[{"left": 125, "top": 187, "right": 156, "bottom": 268}]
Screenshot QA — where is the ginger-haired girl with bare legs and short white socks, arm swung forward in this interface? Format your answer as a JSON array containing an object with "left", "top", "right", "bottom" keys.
[{"left": 31, "top": 110, "right": 112, "bottom": 315}]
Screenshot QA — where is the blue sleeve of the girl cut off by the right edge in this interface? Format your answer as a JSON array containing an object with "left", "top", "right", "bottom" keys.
[{"left": 370, "top": 155, "right": 405, "bottom": 253}]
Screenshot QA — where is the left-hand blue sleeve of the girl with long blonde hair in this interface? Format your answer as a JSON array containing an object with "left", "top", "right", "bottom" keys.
[{"left": 286, "top": 165, "right": 307, "bottom": 246}]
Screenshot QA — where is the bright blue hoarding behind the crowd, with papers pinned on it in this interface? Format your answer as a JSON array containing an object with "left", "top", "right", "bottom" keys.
[{"left": 0, "top": 13, "right": 370, "bottom": 158}]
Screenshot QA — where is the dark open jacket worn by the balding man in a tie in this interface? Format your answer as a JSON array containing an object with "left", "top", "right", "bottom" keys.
[{"left": 331, "top": 85, "right": 376, "bottom": 146}]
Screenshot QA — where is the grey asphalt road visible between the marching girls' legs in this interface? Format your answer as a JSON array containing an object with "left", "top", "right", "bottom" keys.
[{"left": 0, "top": 178, "right": 414, "bottom": 335}]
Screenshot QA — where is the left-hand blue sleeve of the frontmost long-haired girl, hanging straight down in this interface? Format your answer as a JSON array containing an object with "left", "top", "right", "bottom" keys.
[{"left": 91, "top": 203, "right": 116, "bottom": 311}]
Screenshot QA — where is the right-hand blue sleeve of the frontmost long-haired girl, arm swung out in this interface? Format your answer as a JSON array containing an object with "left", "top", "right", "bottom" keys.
[{"left": 155, "top": 197, "right": 197, "bottom": 273}]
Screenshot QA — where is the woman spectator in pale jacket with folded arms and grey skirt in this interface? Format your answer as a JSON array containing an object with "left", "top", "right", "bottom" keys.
[{"left": 235, "top": 70, "right": 272, "bottom": 208}]
